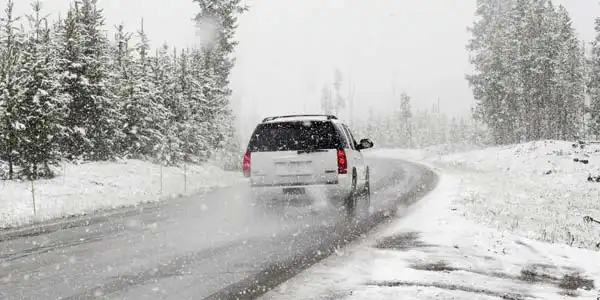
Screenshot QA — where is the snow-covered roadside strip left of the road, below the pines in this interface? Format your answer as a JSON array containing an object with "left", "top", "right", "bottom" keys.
[{"left": 0, "top": 160, "right": 242, "bottom": 228}]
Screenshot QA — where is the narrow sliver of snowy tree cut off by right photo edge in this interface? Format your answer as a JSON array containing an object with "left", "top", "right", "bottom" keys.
[{"left": 587, "top": 8, "right": 600, "bottom": 138}]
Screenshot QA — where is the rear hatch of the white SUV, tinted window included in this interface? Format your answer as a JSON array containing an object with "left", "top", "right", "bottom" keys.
[{"left": 247, "top": 121, "right": 341, "bottom": 186}]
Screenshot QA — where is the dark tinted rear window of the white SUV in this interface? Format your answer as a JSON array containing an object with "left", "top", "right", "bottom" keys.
[{"left": 248, "top": 121, "right": 341, "bottom": 152}]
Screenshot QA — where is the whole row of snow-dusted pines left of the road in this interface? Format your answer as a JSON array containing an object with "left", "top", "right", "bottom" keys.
[{"left": 0, "top": 0, "right": 245, "bottom": 178}]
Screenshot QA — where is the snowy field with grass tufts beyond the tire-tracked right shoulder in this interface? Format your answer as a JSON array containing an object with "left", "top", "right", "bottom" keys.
[{"left": 375, "top": 141, "right": 600, "bottom": 249}]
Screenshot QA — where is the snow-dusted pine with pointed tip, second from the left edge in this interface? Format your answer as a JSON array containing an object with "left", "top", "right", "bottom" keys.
[{"left": 15, "top": 1, "right": 66, "bottom": 180}]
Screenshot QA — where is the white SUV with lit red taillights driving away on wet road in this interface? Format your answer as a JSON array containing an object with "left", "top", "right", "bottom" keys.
[{"left": 243, "top": 115, "right": 373, "bottom": 216}]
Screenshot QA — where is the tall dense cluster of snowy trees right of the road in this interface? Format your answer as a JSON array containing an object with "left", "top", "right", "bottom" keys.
[{"left": 467, "top": 0, "right": 588, "bottom": 144}]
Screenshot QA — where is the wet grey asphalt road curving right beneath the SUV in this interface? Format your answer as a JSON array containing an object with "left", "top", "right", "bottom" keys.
[{"left": 0, "top": 159, "right": 435, "bottom": 300}]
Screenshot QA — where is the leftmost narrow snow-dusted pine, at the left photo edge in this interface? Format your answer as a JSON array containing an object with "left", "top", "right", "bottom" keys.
[{"left": 0, "top": 0, "right": 24, "bottom": 179}]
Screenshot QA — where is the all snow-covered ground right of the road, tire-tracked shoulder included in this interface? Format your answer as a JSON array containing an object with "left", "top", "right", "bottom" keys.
[{"left": 263, "top": 141, "right": 600, "bottom": 300}]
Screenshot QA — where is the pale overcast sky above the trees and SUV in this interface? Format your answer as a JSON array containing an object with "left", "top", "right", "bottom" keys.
[{"left": 0, "top": 0, "right": 600, "bottom": 131}]
